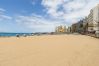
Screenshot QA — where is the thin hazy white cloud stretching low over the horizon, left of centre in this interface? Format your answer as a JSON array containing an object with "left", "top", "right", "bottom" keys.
[{"left": 16, "top": 14, "right": 65, "bottom": 32}]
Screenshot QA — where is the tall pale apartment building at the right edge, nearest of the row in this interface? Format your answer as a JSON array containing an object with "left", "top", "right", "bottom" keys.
[{"left": 87, "top": 4, "right": 99, "bottom": 31}]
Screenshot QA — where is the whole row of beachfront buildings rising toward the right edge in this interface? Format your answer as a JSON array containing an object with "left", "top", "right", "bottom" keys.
[{"left": 71, "top": 4, "right": 99, "bottom": 37}]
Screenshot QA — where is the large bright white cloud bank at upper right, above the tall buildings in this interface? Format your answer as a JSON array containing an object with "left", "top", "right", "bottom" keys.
[{"left": 42, "top": 0, "right": 99, "bottom": 23}]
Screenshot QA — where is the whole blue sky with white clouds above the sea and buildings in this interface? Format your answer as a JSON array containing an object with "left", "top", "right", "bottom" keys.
[{"left": 0, "top": 0, "right": 99, "bottom": 33}]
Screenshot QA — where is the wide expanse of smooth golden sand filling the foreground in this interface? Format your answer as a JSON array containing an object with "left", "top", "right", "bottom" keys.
[{"left": 0, "top": 35, "right": 99, "bottom": 66}]
